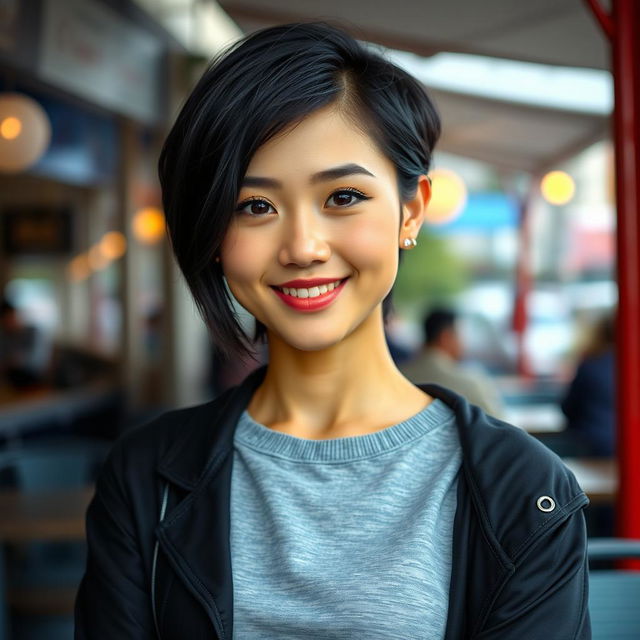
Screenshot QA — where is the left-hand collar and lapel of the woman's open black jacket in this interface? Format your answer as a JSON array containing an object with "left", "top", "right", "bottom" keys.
[{"left": 156, "top": 368, "right": 266, "bottom": 640}]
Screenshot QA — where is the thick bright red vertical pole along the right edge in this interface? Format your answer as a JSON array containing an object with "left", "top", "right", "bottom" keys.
[{"left": 587, "top": 0, "right": 640, "bottom": 538}]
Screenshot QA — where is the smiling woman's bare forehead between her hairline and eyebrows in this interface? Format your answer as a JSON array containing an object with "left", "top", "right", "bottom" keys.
[{"left": 247, "top": 106, "right": 395, "bottom": 176}]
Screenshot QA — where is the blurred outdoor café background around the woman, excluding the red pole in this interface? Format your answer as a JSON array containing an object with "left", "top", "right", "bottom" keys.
[{"left": 0, "top": 0, "right": 640, "bottom": 640}]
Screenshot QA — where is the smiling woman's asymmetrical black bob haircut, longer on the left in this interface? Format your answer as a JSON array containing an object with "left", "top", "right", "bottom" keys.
[{"left": 158, "top": 23, "right": 440, "bottom": 357}]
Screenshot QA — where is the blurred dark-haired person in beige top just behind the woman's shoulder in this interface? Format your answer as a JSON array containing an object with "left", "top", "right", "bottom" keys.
[{"left": 400, "top": 309, "right": 503, "bottom": 417}]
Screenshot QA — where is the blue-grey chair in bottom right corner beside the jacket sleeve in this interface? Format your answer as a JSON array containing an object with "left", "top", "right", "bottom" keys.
[{"left": 588, "top": 538, "right": 640, "bottom": 640}]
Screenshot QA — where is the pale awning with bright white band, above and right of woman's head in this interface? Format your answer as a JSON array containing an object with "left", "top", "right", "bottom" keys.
[{"left": 221, "top": 0, "right": 613, "bottom": 173}]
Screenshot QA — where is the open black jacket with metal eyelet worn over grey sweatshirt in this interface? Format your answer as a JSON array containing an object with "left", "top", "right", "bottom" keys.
[{"left": 75, "top": 369, "right": 591, "bottom": 640}]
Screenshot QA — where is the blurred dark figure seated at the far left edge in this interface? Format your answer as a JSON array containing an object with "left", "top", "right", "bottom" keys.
[{"left": 0, "top": 298, "right": 48, "bottom": 390}]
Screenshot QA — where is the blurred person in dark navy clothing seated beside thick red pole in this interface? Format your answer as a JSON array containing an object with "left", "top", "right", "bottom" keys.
[{"left": 561, "top": 316, "right": 616, "bottom": 457}]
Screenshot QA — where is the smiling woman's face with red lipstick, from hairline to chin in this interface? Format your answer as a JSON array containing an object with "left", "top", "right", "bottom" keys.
[{"left": 221, "top": 107, "right": 419, "bottom": 351}]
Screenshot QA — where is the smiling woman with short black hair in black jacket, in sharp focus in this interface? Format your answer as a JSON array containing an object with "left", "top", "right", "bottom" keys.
[{"left": 76, "top": 24, "right": 589, "bottom": 640}]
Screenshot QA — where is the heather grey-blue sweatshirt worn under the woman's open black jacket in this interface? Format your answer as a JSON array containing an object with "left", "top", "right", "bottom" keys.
[{"left": 231, "top": 400, "right": 461, "bottom": 640}]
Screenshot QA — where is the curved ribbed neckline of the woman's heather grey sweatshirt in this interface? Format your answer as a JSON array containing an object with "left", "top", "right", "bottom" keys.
[{"left": 235, "top": 398, "right": 453, "bottom": 462}]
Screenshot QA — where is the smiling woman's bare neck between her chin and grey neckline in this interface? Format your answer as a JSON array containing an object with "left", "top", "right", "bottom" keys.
[{"left": 249, "top": 309, "right": 429, "bottom": 439}]
